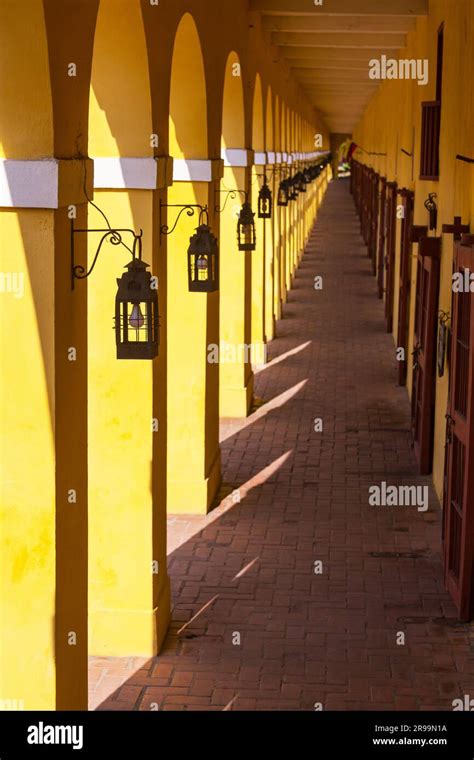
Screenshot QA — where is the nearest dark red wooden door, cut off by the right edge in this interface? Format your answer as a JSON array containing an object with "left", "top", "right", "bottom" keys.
[{"left": 444, "top": 243, "right": 474, "bottom": 620}]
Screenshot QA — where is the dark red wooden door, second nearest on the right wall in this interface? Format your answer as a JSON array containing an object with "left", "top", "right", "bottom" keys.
[{"left": 411, "top": 237, "right": 441, "bottom": 475}]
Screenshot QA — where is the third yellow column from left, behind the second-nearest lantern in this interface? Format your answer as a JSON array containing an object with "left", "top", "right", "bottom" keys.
[{"left": 166, "top": 182, "right": 223, "bottom": 514}]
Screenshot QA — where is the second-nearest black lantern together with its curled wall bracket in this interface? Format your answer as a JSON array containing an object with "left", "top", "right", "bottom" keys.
[{"left": 160, "top": 201, "right": 219, "bottom": 293}]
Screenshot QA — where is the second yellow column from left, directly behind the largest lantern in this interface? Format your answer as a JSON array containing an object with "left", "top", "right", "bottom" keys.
[{"left": 88, "top": 178, "right": 169, "bottom": 656}]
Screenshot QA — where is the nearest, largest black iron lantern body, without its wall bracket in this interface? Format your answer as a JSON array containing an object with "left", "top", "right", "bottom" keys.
[{"left": 115, "top": 239, "right": 159, "bottom": 359}]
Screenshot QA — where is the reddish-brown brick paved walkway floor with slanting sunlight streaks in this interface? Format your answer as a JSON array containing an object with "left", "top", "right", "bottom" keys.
[{"left": 90, "top": 182, "right": 474, "bottom": 710}]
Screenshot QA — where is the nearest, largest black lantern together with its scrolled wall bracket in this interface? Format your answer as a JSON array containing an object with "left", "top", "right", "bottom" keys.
[{"left": 71, "top": 205, "right": 159, "bottom": 359}]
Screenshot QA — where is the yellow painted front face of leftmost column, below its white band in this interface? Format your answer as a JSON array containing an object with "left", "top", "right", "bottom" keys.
[{"left": 0, "top": 210, "right": 56, "bottom": 709}]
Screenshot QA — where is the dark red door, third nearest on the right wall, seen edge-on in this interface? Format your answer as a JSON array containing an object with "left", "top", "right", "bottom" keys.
[{"left": 397, "top": 188, "right": 414, "bottom": 385}]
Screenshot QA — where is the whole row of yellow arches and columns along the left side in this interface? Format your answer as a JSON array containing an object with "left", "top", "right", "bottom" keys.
[{"left": 0, "top": 0, "right": 329, "bottom": 709}]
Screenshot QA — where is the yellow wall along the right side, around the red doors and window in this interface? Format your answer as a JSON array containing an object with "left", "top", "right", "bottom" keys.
[{"left": 354, "top": 0, "right": 474, "bottom": 498}]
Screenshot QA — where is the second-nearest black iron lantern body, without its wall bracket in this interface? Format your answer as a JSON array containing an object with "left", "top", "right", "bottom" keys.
[{"left": 188, "top": 224, "right": 219, "bottom": 293}]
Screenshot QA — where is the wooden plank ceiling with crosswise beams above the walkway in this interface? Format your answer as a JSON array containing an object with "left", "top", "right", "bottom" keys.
[{"left": 250, "top": 0, "right": 429, "bottom": 134}]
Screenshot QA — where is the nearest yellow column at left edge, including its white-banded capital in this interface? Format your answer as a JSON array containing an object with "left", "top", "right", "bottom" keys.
[{"left": 0, "top": 160, "right": 87, "bottom": 710}]
